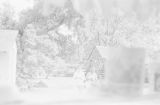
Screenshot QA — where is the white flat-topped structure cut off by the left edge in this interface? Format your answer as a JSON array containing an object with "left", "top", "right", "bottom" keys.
[{"left": 0, "top": 30, "right": 18, "bottom": 102}]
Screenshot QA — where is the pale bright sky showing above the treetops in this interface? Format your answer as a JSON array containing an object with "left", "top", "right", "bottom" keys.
[{"left": 0, "top": 0, "right": 152, "bottom": 21}]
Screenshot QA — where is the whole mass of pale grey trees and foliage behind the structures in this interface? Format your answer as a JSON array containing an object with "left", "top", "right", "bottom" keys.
[{"left": 0, "top": 0, "right": 160, "bottom": 88}]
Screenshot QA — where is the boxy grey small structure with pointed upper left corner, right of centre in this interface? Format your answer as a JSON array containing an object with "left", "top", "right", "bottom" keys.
[{"left": 97, "top": 46, "right": 145, "bottom": 95}]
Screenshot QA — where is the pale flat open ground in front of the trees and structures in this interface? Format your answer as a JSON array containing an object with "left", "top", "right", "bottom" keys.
[{"left": 7, "top": 77, "right": 160, "bottom": 105}]
